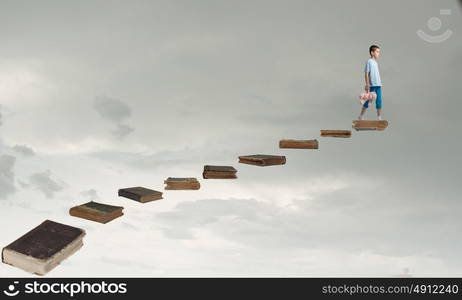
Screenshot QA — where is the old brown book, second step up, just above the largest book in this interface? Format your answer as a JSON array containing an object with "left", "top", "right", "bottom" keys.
[{"left": 69, "top": 201, "right": 124, "bottom": 224}]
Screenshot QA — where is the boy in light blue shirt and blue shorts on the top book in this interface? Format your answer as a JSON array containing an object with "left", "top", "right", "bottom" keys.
[{"left": 358, "top": 45, "right": 382, "bottom": 120}]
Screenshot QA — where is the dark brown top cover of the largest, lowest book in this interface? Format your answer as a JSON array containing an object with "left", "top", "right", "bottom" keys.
[{"left": 2, "top": 220, "right": 85, "bottom": 261}]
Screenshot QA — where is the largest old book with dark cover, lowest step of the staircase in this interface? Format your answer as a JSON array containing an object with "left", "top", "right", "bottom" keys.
[{"left": 2, "top": 220, "right": 85, "bottom": 275}]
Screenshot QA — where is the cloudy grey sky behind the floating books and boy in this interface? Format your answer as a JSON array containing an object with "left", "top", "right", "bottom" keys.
[{"left": 0, "top": 0, "right": 462, "bottom": 277}]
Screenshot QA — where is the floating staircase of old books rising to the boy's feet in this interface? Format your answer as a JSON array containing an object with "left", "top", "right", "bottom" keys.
[{"left": 2, "top": 120, "right": 388, "bottom": 275}]
